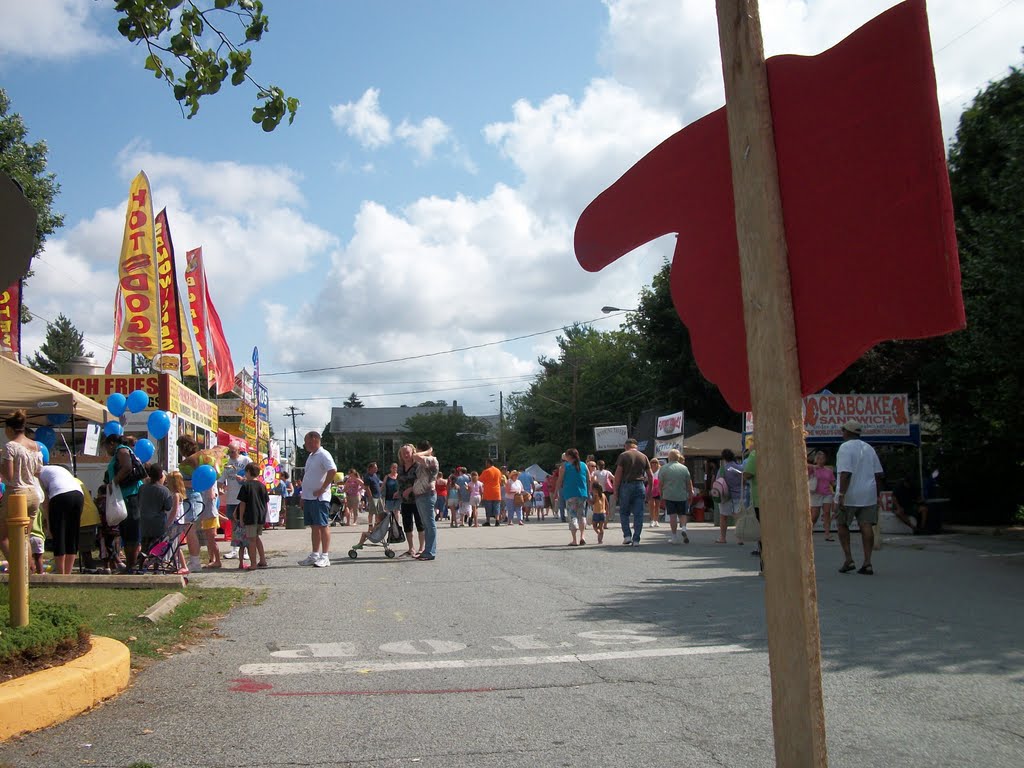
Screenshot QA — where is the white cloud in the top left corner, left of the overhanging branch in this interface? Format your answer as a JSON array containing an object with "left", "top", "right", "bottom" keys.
[{"left": 0, "top": 0, "right": 115, "bottom": 59}]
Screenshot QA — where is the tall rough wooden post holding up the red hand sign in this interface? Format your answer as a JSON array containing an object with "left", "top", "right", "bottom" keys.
[{"left": 716, "top": 0, "right": 828, "bottom": 768}]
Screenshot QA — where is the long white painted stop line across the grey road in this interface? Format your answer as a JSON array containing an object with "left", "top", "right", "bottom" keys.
[{"left": 239, "top": 645, "right": 749, "bottom": 675}]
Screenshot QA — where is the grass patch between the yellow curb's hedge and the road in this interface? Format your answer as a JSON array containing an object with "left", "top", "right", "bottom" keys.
[{"left": 0, "top": 584, "right": 253, "bottom": 669}]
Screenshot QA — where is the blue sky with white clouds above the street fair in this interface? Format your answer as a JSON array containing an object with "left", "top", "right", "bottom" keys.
[{"left": 0, "top": 0, "right": 1024, "bottom": 444}]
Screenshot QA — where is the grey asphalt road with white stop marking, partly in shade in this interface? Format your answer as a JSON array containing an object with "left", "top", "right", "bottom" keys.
[{"left": 0, "top": 522, "right": 1024, "bottom": 768}]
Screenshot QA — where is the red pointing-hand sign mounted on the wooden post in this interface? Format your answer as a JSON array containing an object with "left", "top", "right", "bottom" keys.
[{"left": 575, "top": 0, "right": 966, "bottom": 411}]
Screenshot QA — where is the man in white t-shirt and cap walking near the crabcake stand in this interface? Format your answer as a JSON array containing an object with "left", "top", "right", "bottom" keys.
[{"left": 836, "top": 421, "right": 882, "bottom": 575}]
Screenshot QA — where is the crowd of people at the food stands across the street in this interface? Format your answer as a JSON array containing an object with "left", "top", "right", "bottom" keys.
[{"left": 0, "top": 411, "right": 912, "bottom": 574}]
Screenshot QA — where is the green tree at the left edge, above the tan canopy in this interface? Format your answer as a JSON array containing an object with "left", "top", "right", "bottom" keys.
[{"left": 0, "top": 88, "right": 63, "bottom": 323}]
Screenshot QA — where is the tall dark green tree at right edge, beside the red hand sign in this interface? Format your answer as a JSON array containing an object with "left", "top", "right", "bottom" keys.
[{"left": 931, "top": 60, "right": 1024, "bottom": 522}]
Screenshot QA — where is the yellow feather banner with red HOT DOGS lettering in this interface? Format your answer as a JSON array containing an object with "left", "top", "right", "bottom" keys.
[{"left": 118, "top": 171, "right": 160, "bottom": 359}]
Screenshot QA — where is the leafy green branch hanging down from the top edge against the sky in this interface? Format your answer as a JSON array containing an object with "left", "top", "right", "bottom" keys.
[{"left": 115, "top": 0, "right": 299, "bottom": 131}]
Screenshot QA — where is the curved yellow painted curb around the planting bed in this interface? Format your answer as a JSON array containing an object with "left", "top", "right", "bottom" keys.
[{"left": 0, "top": 636, "right": 131, "bottom": 741}]
